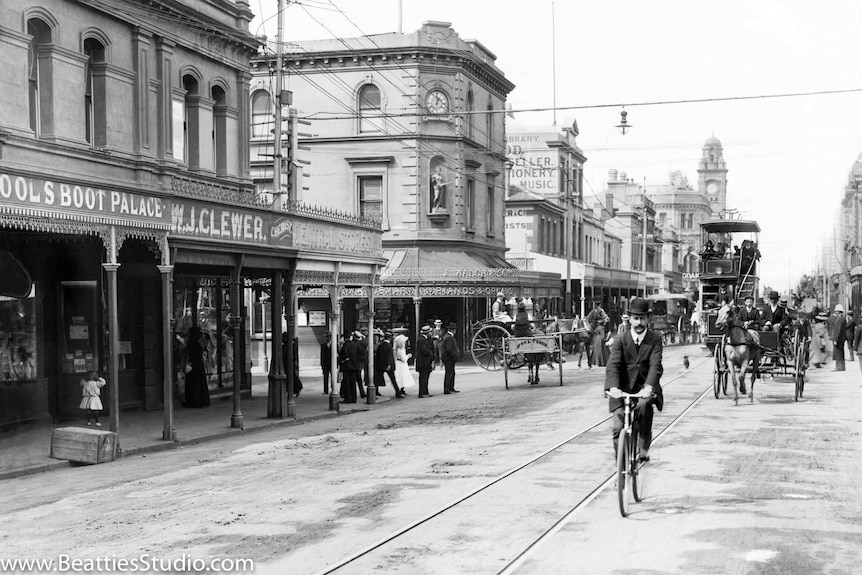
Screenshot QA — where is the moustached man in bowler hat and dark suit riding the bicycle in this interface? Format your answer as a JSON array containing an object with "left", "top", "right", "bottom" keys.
[{"left": 605, "top": 298, "right": 664, "bottom": 461}]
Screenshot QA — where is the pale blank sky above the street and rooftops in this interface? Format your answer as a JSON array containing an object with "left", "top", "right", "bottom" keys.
[{"left": 249, "top": 0, "right": 862, "bottom": 291}]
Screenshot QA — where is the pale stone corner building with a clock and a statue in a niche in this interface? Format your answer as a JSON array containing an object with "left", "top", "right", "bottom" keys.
[{"left": 251, "top": 21, "right": 561, "bottom": 357}]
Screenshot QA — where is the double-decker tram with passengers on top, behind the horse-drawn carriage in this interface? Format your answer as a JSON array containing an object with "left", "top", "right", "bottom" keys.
[{"left": 698, "top": 220, "right": 760, "bottom": 350}]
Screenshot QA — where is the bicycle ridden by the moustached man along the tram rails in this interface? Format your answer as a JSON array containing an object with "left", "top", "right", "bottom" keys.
[{"left": 605, "top": 391, "right": 647, "bottom": 517}]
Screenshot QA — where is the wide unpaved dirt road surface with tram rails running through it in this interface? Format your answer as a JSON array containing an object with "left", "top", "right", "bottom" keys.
[{"left": 0, "top": 346, "right": 862, "bottom": 574}]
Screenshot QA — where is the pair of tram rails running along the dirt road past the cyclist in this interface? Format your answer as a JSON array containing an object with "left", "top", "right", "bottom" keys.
[{"left": 317, "top": 356, "right": 712, "bottom": 575}]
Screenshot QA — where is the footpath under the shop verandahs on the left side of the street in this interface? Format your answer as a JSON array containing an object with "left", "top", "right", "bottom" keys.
[{"left": 0, "top": 361, "right": 502, "bottom": 480}]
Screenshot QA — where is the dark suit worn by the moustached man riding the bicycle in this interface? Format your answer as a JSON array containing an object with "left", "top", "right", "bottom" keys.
[{"left": 605, "top": 329, "right": 664, "bottom": 453}]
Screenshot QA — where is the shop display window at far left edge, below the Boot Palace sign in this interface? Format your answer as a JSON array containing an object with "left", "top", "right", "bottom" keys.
[{"left": 0, "top": 286, "right": 40, "bottom": 381}]
